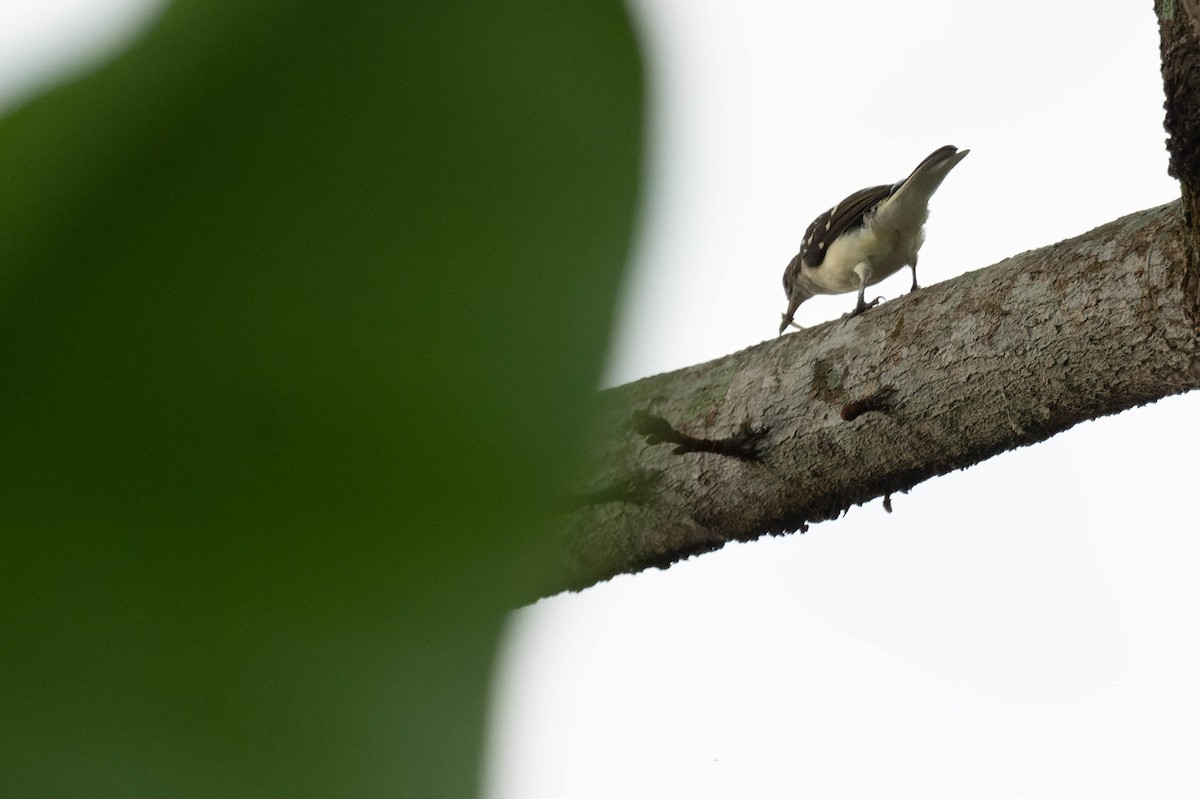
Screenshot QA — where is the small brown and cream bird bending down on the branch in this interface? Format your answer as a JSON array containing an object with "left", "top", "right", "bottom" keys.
[{"left": 779, "top": 145, "right": 971, "bottom": 335}]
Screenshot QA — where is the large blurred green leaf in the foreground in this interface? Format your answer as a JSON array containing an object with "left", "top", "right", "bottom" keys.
[{"left": 0, "top": 0, "right": 642, "bottom": 798}]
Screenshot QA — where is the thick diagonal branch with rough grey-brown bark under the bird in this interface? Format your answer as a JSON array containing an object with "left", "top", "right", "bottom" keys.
[{"left": 557, "top": 203, "right": 1200, "bottom": 589}]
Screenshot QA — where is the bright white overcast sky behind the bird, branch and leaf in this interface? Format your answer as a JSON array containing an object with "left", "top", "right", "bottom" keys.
[{"left": 0, "top": 0, "right": 1200, "bottom": 799}]
